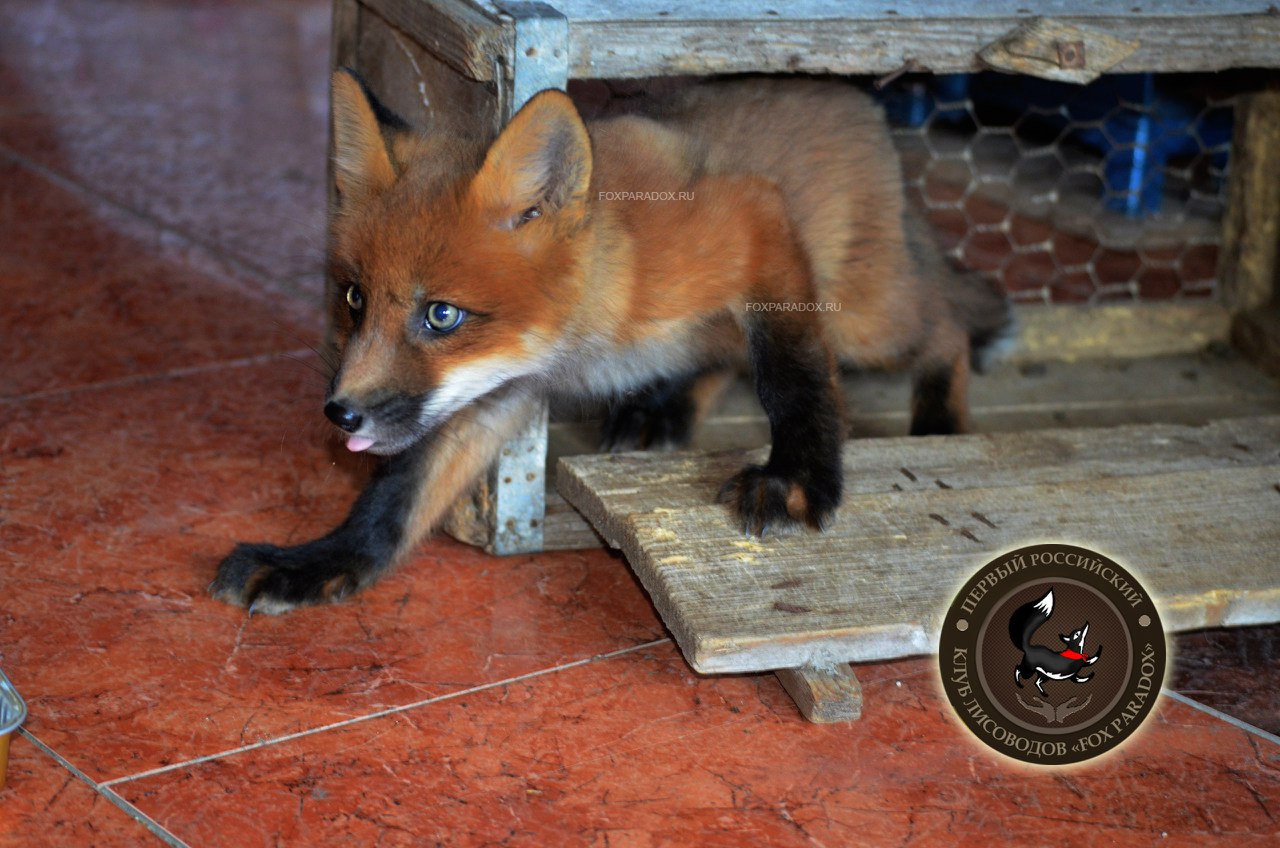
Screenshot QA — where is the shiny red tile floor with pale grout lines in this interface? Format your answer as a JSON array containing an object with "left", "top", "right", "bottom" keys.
[{"left": 0, "top": 0, "right": 1280, "bottom": 848}]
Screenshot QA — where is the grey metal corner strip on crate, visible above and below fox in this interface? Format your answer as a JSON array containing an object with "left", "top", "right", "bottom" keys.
[{"left": 488, "top": 3, "right": 568, "bottom": 553}]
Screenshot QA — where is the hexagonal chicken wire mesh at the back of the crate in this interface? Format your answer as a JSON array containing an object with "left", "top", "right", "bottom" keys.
[{"left": 883, "top": 74, "right": 1238, "bottom": 304}]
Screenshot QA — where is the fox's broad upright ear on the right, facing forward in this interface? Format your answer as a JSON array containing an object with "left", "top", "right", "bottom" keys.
[{"left": 472, "top": 88, "right": 591, "bottom": 227}]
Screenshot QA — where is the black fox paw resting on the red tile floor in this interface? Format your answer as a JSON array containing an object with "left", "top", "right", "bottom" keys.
[{"left": 209, "top": 539, "right": 371, "bottom": 615}]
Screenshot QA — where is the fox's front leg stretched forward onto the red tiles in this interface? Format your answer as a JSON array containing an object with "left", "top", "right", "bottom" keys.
[{"left": 209, "top": 387, "right": 539, "bottom": 614}]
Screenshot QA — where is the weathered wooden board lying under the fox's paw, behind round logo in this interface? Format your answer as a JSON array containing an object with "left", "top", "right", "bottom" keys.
[{"left": 557, "top": 416, "right": 1280, "bottom": 673}]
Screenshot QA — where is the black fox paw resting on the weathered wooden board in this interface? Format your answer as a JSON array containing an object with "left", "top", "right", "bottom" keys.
[{"left": 719, "top": 465, "right": 840, "bottom": 537}]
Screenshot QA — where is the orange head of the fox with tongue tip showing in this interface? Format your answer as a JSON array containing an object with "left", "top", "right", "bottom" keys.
[{"left": 325, "top": 70, "right": 591, "bottom": 453}]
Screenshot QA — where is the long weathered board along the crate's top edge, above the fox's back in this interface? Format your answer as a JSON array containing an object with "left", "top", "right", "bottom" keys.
[{"left": 477, "top": 0, "right": 1280, "bottom": 79}]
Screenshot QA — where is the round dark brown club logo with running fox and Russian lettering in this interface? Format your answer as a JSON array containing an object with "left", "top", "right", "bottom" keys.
[{"left": 938, "top": 544, "right": 1166, "bottom": 765}]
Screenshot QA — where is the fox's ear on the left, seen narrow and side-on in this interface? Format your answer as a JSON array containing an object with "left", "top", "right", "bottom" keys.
[{"left": 333, "top": 68, "right": 408, "bottom": 202}]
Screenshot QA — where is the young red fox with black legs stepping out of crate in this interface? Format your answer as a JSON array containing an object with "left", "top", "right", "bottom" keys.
[{"left": 211, "top": 70, "right": 1009, "bottom": 612}]
